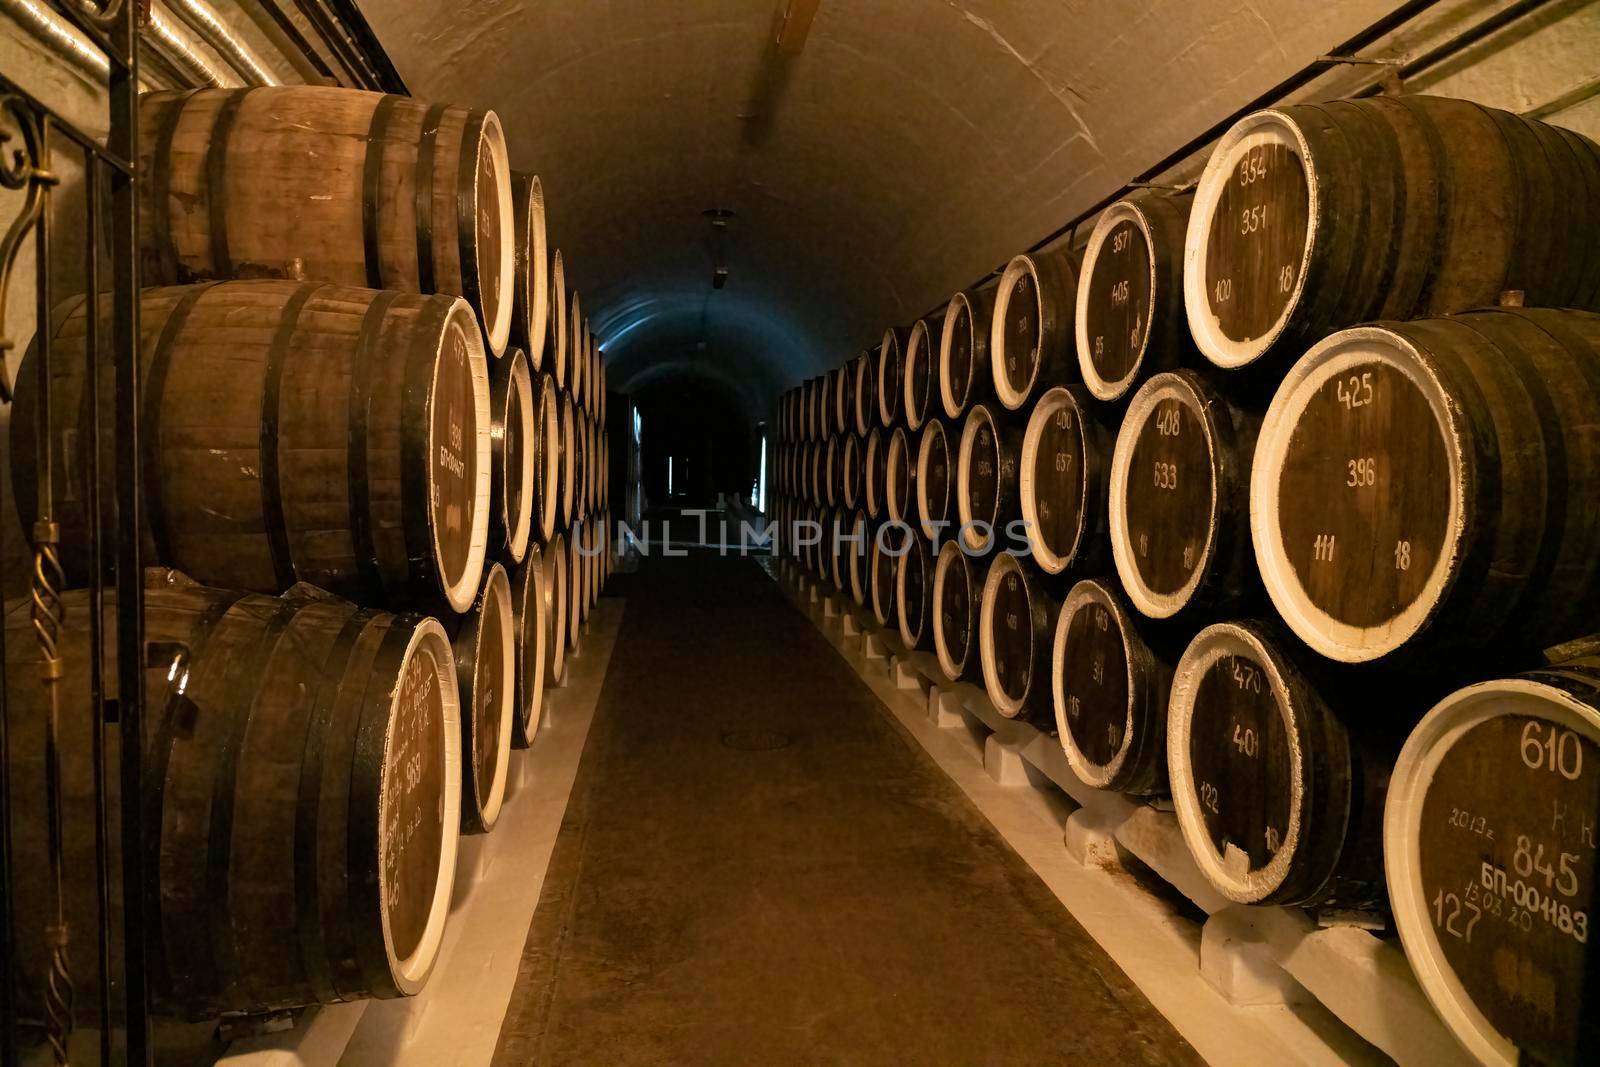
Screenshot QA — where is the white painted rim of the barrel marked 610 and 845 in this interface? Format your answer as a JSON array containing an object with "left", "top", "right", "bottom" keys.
[{"left": 1384, "top": 678, "right": 1600, "bottom": 1067}]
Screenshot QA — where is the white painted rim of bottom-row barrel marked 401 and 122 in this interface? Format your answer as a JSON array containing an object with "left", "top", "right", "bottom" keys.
[{"left": 1166, "top": 622, "right": 1306, "bottom": 904}]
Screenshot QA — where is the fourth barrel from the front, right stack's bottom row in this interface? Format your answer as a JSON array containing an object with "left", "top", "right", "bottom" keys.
[{"left": 978, "top": 552, "right": 1059, "bottom": 723}]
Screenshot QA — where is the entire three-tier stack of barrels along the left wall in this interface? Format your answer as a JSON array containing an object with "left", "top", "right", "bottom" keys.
[{"left": 6, "top": 86, "right": 611, "bottom": 1017}]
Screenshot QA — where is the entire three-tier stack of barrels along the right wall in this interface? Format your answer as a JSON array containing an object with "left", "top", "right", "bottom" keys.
[{"left": 779, "top": 96, "right": 1600, "bottom": 1064}]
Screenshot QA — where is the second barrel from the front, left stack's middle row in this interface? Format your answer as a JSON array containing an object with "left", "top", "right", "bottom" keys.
[{"left": 490, "top": 349, "right": 539, "bottom": 563}]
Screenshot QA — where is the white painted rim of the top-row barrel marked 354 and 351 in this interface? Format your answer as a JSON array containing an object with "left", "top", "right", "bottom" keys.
[{"left": 1184, "top": 109, "right": 1322, "bottom": 370}]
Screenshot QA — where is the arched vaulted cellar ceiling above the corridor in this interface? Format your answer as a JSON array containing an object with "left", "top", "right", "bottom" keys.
[{"left": 362, "top": 0, "right": 1395, "bottom": 411}]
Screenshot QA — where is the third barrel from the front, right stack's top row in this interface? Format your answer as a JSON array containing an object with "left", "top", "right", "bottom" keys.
[{"left": 989, "top": 251, "right": 1078, "bottom": 411}]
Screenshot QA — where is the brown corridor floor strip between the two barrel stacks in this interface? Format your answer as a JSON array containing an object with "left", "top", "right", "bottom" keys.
[{"left": 494, "top": 553, "right": 1202, "bottom": 1065}]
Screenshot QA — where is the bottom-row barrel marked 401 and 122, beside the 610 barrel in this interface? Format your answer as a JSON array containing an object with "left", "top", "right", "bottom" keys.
[{"left": 1166, "top": 622, "right": 1387, "bottom": 909}]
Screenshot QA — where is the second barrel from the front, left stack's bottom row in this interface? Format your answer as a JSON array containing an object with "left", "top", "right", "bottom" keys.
[{"left": 451, "top": 563, "right": 517, "bottom": 833}]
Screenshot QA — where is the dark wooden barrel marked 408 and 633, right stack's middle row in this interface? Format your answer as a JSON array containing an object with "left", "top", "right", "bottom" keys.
[{"left": 1110, "top": 370, "right": 1261, "bottom": 619}]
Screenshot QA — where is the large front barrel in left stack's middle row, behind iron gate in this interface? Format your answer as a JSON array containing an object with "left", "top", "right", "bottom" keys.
[{"left": 11, "top": 282, "right": 491, "bottom": 611}]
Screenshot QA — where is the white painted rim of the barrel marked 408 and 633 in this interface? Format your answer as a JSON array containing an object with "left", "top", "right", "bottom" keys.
[{"left": 1109, "top": 371, "right": 1221, "bottom": 619}]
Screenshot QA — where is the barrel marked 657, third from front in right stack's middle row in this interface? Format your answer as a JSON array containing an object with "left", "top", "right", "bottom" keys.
[{"left": 1018, "top": 386, "right": 1112, "bottom": 574}]
